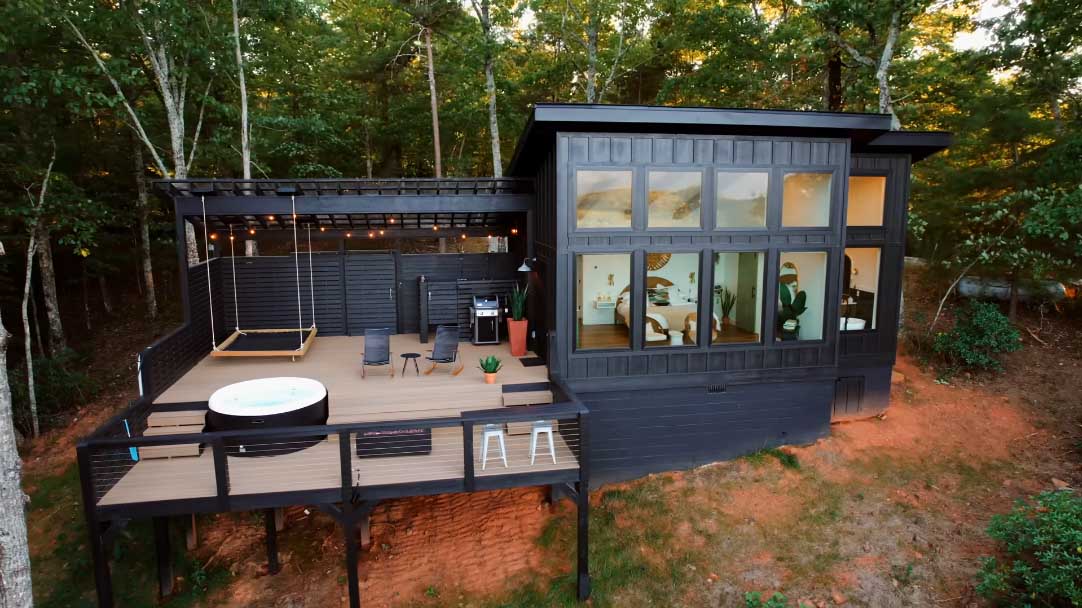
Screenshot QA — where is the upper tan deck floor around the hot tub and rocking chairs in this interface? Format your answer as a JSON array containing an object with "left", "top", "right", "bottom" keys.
[{"left": 155, "top": 334, "right": 549, "bottom": 424}]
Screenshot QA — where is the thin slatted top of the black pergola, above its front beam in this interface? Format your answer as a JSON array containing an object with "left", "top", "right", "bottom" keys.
[{"left": 155, "top": 177, "right": 533, "bottom": 197}]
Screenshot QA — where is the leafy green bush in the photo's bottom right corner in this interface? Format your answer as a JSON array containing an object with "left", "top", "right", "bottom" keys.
[{"left": 977, "top": 490, "right": 1082, "bottom": 608}]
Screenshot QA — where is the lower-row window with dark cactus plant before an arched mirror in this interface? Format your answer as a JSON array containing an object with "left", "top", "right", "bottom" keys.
[{"left": 776, "top": 251, "right": 827, "bottom": 341}]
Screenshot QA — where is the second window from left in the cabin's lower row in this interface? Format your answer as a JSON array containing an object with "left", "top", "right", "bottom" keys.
[{"left": 642, "top": 252, "right": 699, "bottom": 347}]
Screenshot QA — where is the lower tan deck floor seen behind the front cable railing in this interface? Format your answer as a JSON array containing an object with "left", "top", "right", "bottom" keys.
[{"left": 97, "top": 426, "right": 579, "bottom": 506}]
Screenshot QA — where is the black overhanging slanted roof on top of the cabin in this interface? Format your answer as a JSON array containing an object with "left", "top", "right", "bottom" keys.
[{"left": 509, "top": 103, "right": 950, "bottom": 175}]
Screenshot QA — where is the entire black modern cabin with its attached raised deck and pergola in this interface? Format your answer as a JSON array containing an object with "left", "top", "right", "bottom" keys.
[{"left": 78, "top": 104, "right": 950, "bottom": 607}]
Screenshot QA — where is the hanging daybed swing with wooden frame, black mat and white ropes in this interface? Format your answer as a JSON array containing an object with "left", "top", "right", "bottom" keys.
[{"left": 202, "top": 197, "right": 316, "bottom": 360}]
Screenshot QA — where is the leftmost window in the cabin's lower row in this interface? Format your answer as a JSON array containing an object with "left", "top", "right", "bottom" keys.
[{"left": 575, "top": 253, "right": 632, "bottom": 349}]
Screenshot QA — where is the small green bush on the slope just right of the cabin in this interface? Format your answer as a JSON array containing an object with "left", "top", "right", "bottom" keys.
[{"left": 932, "top": 300, "right": 1021, "bottom": 373}]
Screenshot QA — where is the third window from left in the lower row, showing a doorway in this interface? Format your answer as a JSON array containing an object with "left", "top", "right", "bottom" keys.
[{"left": 710, "top": 251, "right": 765, "bottom": 344}]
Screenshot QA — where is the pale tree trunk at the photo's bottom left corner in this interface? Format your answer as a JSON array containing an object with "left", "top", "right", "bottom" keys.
[{"left": 0, "top": 279, "right": 34, "bottom": 608}]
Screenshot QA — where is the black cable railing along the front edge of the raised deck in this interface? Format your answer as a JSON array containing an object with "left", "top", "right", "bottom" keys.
[{"left": 78, "top": 398, "right": 589, "bottom": 513}]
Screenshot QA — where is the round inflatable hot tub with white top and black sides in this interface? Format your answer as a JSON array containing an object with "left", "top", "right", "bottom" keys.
[{"left": 207, "top": 378, "right": 327, "bottom": 457}]
